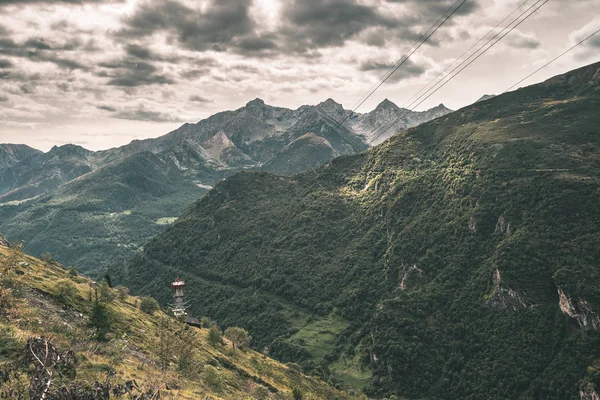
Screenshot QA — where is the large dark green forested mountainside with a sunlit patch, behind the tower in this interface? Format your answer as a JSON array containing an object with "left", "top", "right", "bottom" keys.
[{"left": 114, "top": 64, "right": 600, "bottom": 399}]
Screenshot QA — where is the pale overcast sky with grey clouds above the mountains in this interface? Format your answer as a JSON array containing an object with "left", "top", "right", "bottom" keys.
[{"left": 0, "top": 0, "right": 600, "bottom": 151}]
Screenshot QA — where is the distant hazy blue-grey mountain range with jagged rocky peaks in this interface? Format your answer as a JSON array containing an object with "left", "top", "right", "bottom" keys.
[{"left": 0, "top": 99, "right": 450, "bottom": 273}]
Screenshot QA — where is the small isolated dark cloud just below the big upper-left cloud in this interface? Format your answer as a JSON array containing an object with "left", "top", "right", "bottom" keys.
[{"left": 96, "top": 60, "right": 175, "bottom": 87}]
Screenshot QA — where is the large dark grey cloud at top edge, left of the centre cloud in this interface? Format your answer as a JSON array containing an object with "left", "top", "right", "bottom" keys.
[{"left": 120, "top": 0, "right": 254, "bottom": 51}]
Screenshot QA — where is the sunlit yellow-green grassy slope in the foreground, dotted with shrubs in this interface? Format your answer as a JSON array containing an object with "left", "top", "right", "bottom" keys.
[{"left": 0, "top": 241, "right": 356, "bottom": 399}]
